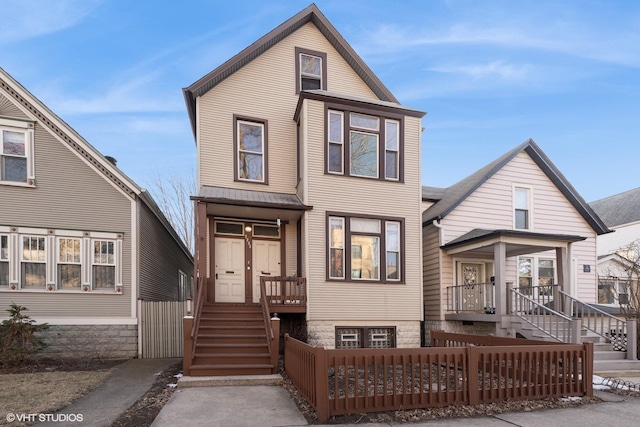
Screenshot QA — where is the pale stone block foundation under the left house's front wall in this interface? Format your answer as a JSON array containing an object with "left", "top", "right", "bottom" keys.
[{"left": 39, "top": 325, "right": 138, "bottom": 359}]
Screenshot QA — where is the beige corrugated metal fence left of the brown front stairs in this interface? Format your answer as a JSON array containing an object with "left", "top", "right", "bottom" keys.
[{"left": 139, "top": 301, "right": 187, "bottom": 359}]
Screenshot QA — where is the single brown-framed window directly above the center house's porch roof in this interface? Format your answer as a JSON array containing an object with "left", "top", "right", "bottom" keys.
[{"left": 234, "top": 117, "right": 268, "bottom": 184}]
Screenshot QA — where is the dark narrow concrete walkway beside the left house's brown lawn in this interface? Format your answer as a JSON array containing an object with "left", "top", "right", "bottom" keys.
[{"left": 36, "top": 359, "right": 181, "bottom": 427}]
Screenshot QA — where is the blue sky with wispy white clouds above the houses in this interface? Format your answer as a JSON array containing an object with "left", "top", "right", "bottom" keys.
[{"left": 0, "top": 0, "right": 640, "bottom": 201}]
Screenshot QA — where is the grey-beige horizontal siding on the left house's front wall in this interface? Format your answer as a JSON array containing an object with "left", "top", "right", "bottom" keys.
[{"left": 0, "top": 110, "right": 132, "bottom": 319}]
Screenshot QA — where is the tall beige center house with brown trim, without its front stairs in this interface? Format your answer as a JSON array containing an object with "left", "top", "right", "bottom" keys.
[{"left": 184, "top": 5, "right": 424, "bottom": 378}]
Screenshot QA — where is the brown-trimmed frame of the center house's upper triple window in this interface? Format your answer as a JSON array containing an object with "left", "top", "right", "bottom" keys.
[{"left": 324, "top": 103, "right": 404, "bottom": 183}]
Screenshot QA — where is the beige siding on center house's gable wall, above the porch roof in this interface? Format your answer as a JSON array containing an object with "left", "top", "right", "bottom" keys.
[{"left": 197, "top": 23, "right": 376, "bottom": 194}]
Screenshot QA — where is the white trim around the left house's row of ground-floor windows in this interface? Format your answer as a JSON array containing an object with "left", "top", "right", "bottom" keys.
[{"left": 0, "top": 226, "right": 123, "bottom": 294}]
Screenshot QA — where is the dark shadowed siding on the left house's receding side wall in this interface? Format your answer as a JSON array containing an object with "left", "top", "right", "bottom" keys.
[{"left": 138, "top": 201, "right": 193, "bottom": 301}]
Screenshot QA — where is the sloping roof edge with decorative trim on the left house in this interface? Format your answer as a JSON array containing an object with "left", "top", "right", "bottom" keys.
[{"left": 0, "top": 67, "right": 193, "bottom": 258}]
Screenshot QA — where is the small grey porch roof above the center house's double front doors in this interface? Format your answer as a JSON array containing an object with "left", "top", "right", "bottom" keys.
[{"left": 191, "top": 185, "right": 313, "bottom": 220}]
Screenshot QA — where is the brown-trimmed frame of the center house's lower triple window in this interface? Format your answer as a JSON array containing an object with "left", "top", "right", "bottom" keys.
[{"left": 325, "top": 212, "right": 406, "bottom": 285}]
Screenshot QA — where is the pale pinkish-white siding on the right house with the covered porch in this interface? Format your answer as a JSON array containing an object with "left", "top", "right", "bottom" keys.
[{"left": 442, "top": 152, "right": 597, "bottom": 302}]
